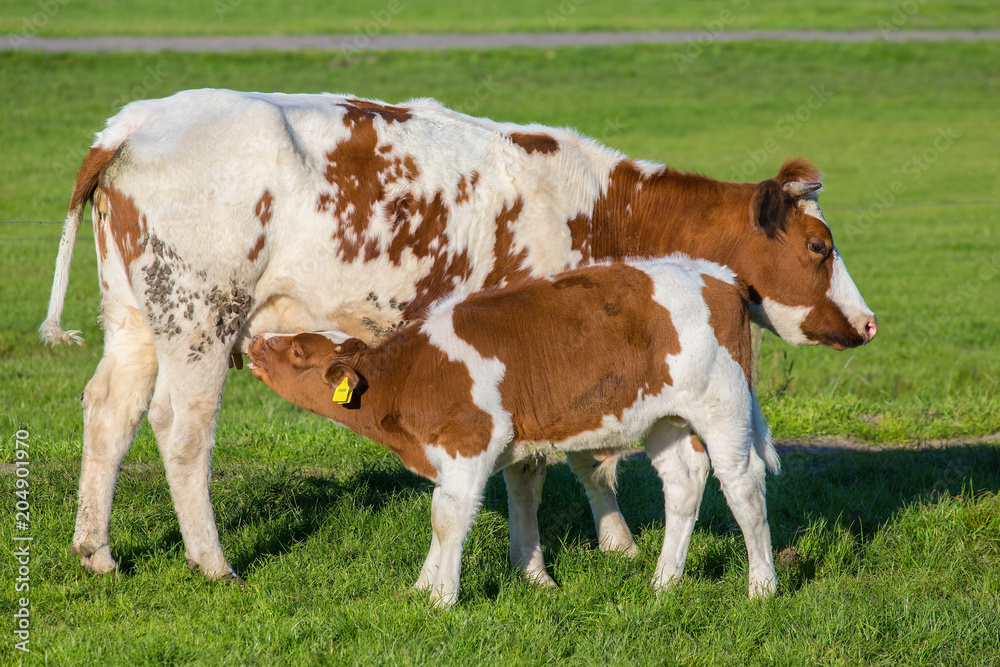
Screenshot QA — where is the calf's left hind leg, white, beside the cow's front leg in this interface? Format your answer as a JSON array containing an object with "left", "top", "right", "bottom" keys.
[{"left": 645, "top": 418, "right": 709, "bottom": 590}]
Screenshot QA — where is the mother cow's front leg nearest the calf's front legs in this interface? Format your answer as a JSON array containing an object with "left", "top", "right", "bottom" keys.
[{"left": 503, "top": 456, "right": 556, "bottom": 587}]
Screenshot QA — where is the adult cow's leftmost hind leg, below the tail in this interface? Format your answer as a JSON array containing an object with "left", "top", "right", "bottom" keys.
[{"left": 72, "top": 298, "right": 157, "bottom": 573}]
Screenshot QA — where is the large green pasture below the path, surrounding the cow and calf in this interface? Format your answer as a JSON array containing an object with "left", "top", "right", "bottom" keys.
[{"left": 0, "top": 40, "right": 1000, "bottom": 665}]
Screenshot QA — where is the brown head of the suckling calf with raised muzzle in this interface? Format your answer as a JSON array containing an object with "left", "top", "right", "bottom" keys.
[{"left": 248, "top": 332, "right": 367, "bottom": 412}]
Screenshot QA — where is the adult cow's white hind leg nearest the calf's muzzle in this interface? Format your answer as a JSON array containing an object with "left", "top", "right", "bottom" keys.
[{"left": 149, "top": 340, "right": 236, "bottom": 580}]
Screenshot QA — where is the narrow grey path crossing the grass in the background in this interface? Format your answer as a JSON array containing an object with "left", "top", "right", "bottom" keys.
[{"left": 7, "top": 30, "right": 1000, "bottom": 53}]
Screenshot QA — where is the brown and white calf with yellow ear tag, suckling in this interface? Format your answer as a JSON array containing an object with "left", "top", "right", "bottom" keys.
[{"left": 249, "top": 257, "right": 778, "bottom": 604}]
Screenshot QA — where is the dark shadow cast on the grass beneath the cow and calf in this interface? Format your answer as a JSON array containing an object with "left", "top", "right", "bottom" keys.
[{"left": 88, "top": 444, "right": 1000, "bottom": 590}]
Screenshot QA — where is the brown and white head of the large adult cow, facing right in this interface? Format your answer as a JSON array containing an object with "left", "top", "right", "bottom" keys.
[{"left": 732, "top": 160, "right": 877, "bottom": 350}]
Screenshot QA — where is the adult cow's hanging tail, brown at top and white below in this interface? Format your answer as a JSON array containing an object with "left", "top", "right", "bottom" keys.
[{"left": 38, "top": 146, "right": 114, "bottom": 345}]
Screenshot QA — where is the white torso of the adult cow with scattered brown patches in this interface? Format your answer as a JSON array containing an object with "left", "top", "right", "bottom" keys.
[{"left": 96, "top": 90, "right": 618, "bottom": 345}]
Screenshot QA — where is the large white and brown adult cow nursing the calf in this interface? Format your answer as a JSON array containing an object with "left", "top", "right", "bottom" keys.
[{"left": 41, "top": 90, "right": 875, "bottom": 583}]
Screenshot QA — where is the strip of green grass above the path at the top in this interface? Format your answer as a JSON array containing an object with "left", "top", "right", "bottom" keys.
[{"left": 0, "top": 0, "right": 1000, "bottom": 37}]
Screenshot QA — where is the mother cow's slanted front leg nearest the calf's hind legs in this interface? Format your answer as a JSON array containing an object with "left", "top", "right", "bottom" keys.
[{"left": 566, "top": 451, "right": 639, "bottom": 556}]
